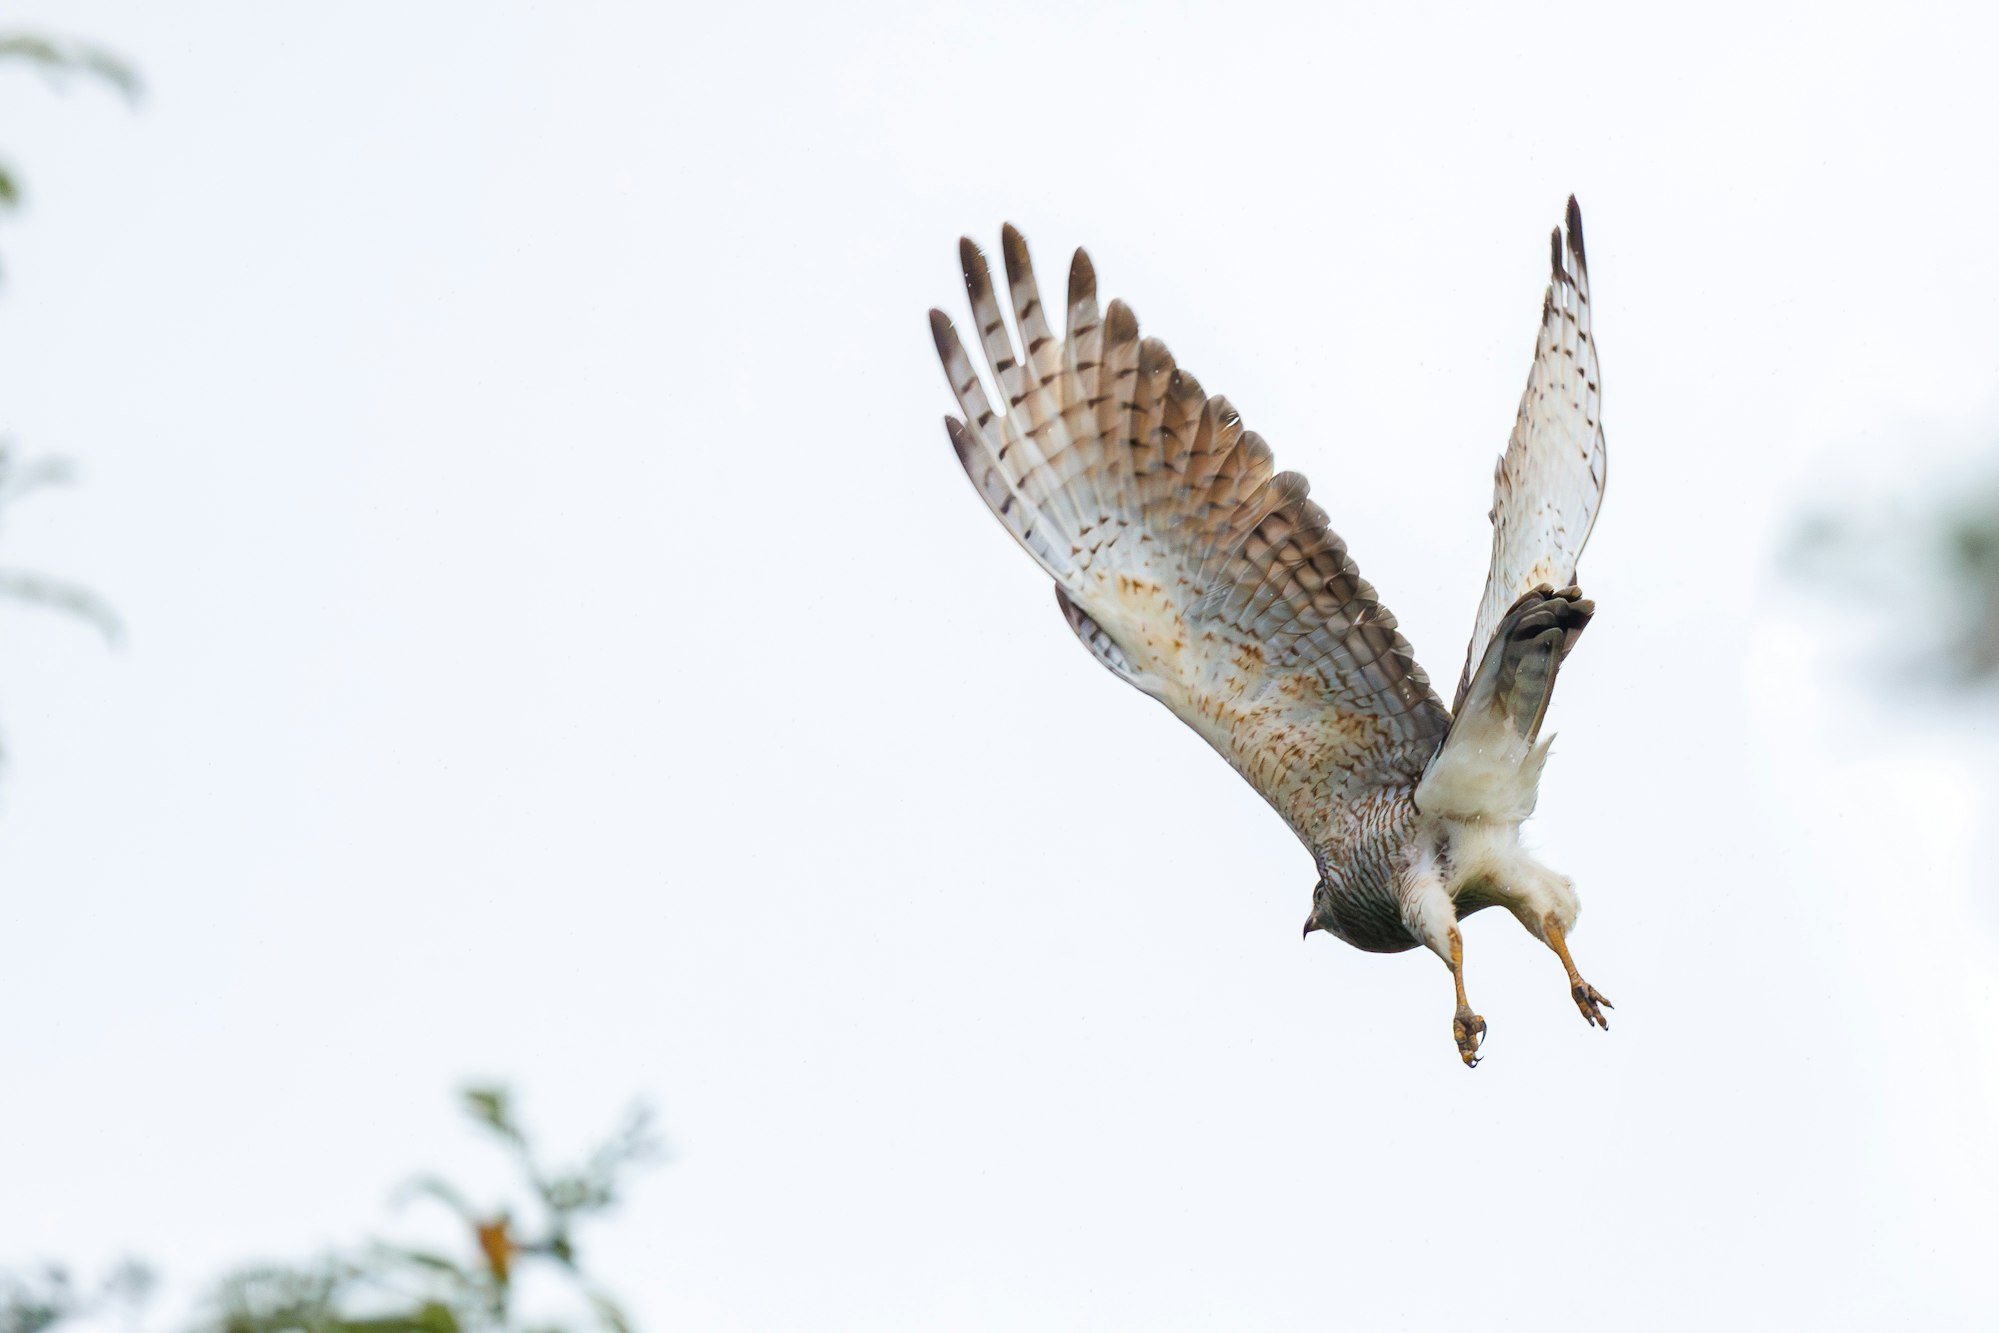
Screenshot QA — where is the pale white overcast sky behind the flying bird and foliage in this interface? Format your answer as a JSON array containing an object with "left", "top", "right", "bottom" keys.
[{"left": 0, "top": 0, "right": 1999, "bottom": 1333}]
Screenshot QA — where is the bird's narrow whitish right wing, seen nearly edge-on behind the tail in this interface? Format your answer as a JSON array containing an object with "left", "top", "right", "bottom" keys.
[{"left": 1451, "top": 194, "right": 1603, "bottom": 709}]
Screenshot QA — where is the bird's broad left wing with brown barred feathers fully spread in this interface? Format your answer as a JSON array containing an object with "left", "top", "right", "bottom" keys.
[{"left": 930, "top": 226, "right": 1449, "bottom": 845}]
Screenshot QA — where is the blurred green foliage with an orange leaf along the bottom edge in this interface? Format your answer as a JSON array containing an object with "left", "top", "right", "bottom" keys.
[{"left": 0, "top": 1087, "right": 662, "bottom": 1333}]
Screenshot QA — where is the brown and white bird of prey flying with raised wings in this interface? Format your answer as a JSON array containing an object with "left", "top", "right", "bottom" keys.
[{"left": 930, "top": 198, "right": 1609, "bottom": 1067}]
